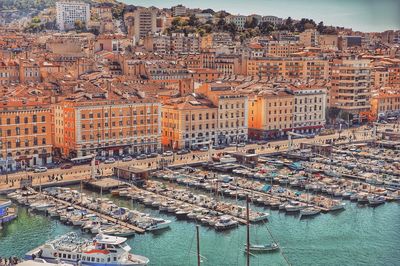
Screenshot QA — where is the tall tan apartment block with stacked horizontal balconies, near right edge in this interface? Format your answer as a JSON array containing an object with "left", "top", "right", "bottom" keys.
[{"left": 329, "top": 58, "right": 371, "bottom": 114}]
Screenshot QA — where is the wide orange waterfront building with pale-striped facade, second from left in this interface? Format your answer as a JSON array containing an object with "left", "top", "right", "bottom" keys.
[{"left": 54, "top": 98, "right": 161, "bottom": 158}]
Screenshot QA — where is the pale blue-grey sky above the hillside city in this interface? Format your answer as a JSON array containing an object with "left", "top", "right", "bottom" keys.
[{"left": 119, "top": 0, "right": 400, "bottom": 32}]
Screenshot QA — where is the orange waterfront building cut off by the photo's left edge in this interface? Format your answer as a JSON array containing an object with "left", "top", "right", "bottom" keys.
[{"left": 0, "top": 100, "right": 53, "bottom": 171}]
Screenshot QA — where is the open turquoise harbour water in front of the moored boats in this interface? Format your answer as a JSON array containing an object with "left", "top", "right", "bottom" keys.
[{"left": 0, "top": 190, "right": 400, "bottom": 266}]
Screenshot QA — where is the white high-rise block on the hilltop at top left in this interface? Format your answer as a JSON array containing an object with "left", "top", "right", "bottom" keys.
[{"left": 56, "top": 2, "right": 90, "bottom": 31}]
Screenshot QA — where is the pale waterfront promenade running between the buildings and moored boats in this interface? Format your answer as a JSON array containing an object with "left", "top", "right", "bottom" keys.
[{"left": 0, "top": 127, "right": 384, "bottom": 190}]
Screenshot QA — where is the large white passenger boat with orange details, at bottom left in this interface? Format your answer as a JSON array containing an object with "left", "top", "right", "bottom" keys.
[{"left": 25, "top": 233, "right": 149, "bottom": 266}]
